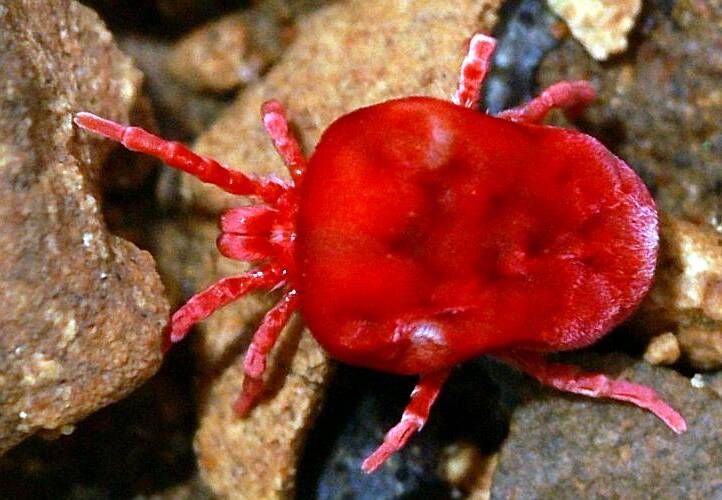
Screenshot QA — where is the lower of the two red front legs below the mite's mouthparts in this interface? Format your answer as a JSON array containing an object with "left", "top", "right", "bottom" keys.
[{"left": 233, "top": 290, "right": 298, "bottom": 416}]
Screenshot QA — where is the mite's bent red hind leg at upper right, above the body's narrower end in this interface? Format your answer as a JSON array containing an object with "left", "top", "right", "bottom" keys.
[{"left": 497, "top": 80, "right": 595, "bottom": 123}]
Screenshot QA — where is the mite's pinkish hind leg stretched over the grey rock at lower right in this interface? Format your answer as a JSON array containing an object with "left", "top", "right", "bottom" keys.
[{"left": 495, "top": 351, "right": 687, "bottom": 434}]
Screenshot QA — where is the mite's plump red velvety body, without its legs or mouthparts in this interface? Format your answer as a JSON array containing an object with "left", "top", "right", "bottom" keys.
[{"left": 296, "top": 97, "right": 658, "bottom": 373}]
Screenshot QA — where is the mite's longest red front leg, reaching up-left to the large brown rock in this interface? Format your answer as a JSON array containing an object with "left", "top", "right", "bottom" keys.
[{"left": 74, "top": 113, "right": 288, "bottom": 203}]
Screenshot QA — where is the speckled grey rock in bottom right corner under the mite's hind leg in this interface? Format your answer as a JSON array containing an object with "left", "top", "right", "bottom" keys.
[{"left": 491, "top": 353, "right": 722, "bottom": 499}]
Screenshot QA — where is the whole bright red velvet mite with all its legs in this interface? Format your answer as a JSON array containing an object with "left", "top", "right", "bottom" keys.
[{"left": 75, "top": 34, "right": 686, "bottom": 472}]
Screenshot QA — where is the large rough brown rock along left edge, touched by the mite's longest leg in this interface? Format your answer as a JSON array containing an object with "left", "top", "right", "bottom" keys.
[{"left": 0, "top": 0, "right": 168, "bottom": 452}]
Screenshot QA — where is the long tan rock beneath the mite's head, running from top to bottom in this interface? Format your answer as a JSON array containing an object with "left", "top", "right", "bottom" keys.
[{"left": 153, "top": 0, "right": 499, "bottom": 498}]
